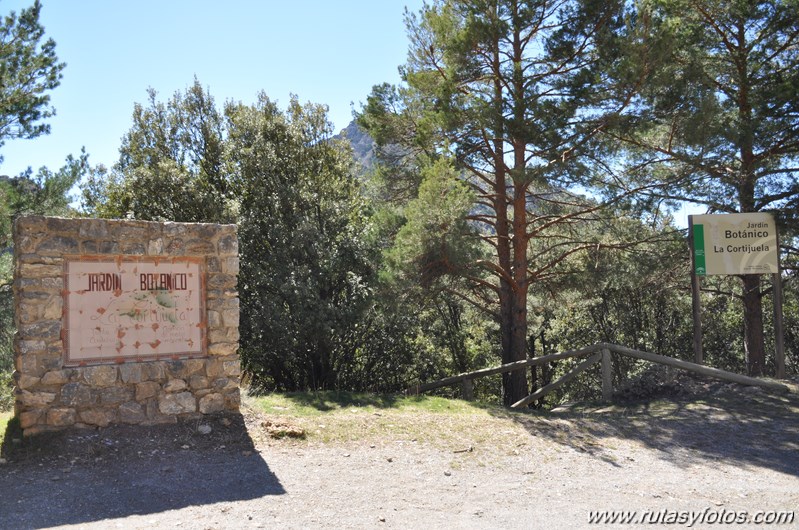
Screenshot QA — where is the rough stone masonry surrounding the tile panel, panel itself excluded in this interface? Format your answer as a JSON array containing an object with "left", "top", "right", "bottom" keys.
[{"left": 14, "top": 217, "right": 241, "bottom": 435}]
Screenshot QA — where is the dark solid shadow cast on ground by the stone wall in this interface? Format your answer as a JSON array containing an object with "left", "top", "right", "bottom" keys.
[{"left": 0, "top": 415, "right": 285, "bottom": 528}]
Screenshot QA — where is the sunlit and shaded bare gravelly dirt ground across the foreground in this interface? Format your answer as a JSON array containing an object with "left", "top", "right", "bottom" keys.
[{"left": 0, "top": 374, "right": 799, "bottom": 530}]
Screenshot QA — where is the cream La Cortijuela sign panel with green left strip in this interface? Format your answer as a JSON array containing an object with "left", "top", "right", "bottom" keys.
[{"left": 691, "top": 213, "right": 779, "bottom": 275}]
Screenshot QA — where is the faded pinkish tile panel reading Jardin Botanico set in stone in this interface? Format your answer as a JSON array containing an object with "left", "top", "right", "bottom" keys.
[{"left": 64, "top": 257, "right": 206, "bottom": 365}]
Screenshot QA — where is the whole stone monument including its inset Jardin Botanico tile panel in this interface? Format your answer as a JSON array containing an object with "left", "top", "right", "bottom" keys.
[{"left": 14, "top": 216, "right": 241, "bottom": 435}]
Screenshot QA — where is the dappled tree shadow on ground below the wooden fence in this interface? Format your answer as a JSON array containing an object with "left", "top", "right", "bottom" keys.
[{"left": 514, "top": 376, "right": 799, "bottom": 476}]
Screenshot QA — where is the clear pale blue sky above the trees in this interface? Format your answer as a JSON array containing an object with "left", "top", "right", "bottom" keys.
[{"left": 0, "top": 0, "right": 422, "bottom": 176}]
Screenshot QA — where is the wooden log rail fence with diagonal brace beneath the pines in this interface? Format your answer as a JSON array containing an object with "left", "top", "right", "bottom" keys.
[{"left": 406, "top": 343, "right": 789, "bottom": 408}]
